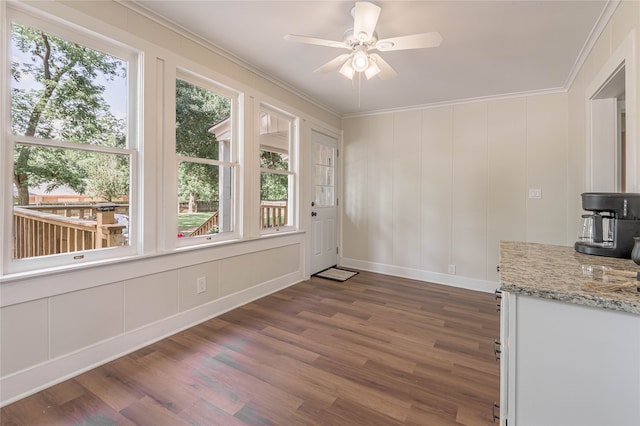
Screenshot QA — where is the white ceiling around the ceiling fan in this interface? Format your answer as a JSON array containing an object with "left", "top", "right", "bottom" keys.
[{"left": 129, "top": 0, "right": 608, "bottom": 116}]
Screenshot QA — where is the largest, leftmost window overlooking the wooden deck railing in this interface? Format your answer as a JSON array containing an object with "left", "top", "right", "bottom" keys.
[{"left": 5, "top": 13, "right": 136, "bottom": 271}]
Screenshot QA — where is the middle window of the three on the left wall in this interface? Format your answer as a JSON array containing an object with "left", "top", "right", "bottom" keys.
[{"left": 176, "top": 73, "right": 238, "bottom": 244}]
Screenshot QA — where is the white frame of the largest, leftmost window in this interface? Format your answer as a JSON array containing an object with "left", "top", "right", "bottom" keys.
[{"left": 0, "top": 5, "right": 142, "bottom": 275}]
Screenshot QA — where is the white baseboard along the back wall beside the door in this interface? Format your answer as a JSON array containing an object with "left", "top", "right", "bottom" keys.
[{"left": 340, "top": 257, "right": 500, "bottom": 293}]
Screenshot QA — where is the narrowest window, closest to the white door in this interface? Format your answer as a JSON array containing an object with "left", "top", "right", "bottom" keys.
[{"left": 259, "top": 106, "right": 296, "bottom": 232}]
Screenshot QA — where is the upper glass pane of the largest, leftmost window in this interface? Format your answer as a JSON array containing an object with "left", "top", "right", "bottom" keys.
[{"left": 10, "top": 22, "right": 127, "bottom": 146}]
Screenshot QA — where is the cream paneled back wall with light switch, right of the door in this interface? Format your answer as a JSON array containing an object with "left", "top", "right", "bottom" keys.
[{"left": 341, "top": 93, "right": 577, "bottom": 291}]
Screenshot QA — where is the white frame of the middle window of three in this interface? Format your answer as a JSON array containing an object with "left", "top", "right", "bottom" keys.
[{"left": 172, "top": 67, "right": 241, "bottom": 249}]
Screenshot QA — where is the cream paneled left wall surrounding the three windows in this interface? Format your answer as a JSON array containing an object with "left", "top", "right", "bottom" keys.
[{"left": 0, "top": 1, "right": 340, "bottom": 405}]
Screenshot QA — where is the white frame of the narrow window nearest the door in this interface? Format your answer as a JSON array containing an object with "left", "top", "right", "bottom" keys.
[{"left": 255, "top": 102, "right": 300, "bottom": 236}]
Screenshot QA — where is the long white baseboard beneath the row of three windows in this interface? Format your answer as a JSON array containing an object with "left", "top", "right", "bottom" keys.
[{"left": 0, "top": 271, "right": 303, "bottom": 407}]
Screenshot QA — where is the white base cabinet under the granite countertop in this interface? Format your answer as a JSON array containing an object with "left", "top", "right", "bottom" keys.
[{"left": 500, "top": 291, "right": 640, "bottom": 426}]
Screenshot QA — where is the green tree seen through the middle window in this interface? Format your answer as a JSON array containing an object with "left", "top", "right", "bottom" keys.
[{"left": 176, "top": 79, "right": 231, "bottom": 213}]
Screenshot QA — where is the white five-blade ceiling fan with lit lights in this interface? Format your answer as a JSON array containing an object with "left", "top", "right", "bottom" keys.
[{"left": 284, "top": 1, "right": 442, "bottom": 80}]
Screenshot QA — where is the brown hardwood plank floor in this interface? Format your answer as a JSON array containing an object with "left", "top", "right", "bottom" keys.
[{"left": 0, "top": 272, "right": 499, "bottom": 426}]
